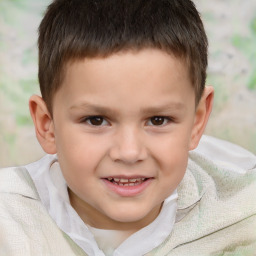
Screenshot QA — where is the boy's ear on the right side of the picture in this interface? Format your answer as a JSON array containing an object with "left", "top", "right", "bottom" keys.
[{"left": 190, "top": 86, "right": 214, "bottom": 150}]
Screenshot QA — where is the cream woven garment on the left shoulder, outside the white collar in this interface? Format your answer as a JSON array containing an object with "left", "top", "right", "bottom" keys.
[{"left": 0, "top": 166, "right": 86, "bottom": 256}]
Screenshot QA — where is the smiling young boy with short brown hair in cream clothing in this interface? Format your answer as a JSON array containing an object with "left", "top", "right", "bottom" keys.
[{"left": 0, "top": 0, "right": 256, "bottom": 256}]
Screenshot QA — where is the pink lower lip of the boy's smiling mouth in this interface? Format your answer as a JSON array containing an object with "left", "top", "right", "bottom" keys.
[{"left": 103, "top": 179, "right": 153, "bottom": 197}]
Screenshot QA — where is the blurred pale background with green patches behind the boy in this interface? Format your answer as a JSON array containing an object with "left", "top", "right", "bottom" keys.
[{"left": 0, "top": 0, "right": 256, "bottom": 167}]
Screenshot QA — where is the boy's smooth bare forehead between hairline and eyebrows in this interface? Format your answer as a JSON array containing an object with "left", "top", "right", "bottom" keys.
[{"left": 54, "top": 49, "right": 193, "bottom": 111}]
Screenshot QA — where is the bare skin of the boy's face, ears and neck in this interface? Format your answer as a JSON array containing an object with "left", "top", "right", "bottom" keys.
[{"left": 30, "top": 49, "right": 213, "bottom": 233}]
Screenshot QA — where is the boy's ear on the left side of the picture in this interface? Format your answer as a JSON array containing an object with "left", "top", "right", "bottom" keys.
[{"left": 29, "top": 95, "right": 56, "bottom": 154}]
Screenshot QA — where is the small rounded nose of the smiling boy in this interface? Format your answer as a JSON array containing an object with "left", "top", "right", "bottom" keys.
[{"left": 110, "top": 127, "right": 147, "bottom": 164}]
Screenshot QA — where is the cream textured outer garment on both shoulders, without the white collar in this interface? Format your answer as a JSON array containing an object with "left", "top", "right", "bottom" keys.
[{"left": 0, "top": 135, "right": 256, "bottom": 256}]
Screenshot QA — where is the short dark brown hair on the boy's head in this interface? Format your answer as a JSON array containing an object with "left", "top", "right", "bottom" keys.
[{"left": 38, "top": 0, "right": 208, "bottom": 113}]
